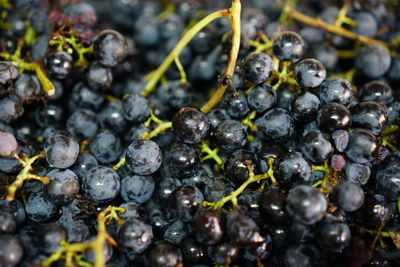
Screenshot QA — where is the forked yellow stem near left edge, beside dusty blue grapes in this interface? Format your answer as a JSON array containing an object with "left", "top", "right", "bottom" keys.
[{"left": 6, "top": 152, "right": 50, "bottom": 202}]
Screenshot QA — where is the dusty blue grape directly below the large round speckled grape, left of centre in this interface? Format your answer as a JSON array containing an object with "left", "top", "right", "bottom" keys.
[{"left": 120, "top": 175, "right": 155, "bottom": 203}]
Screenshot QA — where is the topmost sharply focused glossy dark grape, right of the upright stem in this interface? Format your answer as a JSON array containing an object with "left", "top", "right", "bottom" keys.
[{"left": 272, "top": 31, "right": 306, "bottom": 62}]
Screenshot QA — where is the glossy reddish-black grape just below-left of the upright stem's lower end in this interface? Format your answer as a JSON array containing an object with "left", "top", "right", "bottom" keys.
[{"left": 172, "top": 107, "right": 210, "bottom": 144}]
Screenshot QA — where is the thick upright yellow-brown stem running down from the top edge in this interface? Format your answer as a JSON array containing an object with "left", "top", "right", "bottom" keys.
[{"left": 201, "top": 0, "right": 242, "bottom": 113}]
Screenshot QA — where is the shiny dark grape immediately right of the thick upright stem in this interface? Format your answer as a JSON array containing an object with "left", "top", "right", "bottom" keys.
[{"left": 241, "top": 52, "right": 274, "bottom": 83}]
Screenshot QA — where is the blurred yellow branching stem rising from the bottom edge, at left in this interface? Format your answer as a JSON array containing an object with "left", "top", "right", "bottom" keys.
[{"left": 42, "top": 206, "right": 125, "bottom": 267}]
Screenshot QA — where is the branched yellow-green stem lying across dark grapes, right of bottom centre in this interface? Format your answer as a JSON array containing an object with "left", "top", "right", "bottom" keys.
[{"left": 203, "top": 158, "right": 277, "bottom": 210}]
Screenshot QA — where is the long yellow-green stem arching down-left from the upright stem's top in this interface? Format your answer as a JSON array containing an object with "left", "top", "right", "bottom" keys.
[{"left": 141, "top": 8, "right": 228, "bottom": 96}]
